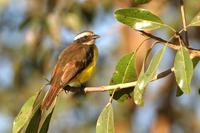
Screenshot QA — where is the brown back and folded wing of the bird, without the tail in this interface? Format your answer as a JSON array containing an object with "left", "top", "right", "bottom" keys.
[{"left": 52, "top": 44, "right": 93, "bottom": 85}]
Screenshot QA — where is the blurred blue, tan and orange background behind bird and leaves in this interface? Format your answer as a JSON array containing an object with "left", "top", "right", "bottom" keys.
[{"left": 0, "top": 0, "right": 200, "bottom": 133}]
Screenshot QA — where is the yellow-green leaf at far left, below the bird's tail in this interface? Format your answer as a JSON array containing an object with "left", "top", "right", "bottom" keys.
[{"left": 12, "top": 96, "right": 36, "bottom": 133}]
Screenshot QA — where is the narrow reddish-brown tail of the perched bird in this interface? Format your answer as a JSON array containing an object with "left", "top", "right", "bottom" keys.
[{"left": 42, "top": 84, "right": 61, "bottom": 110}]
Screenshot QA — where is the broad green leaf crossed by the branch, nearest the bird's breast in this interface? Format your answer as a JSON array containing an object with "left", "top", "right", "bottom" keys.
[{"left": 110, "top": 53, "right": 137, "bottom": 102}]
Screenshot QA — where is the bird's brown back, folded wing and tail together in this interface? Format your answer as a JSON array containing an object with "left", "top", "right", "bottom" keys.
[{"left": 42, "top": 44, "right": 93, "bottom": 109}]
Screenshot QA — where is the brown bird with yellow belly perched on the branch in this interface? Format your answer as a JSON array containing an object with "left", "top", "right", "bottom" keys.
[{"left": 41, "top": 31, "right": 100, "bottom": 110}]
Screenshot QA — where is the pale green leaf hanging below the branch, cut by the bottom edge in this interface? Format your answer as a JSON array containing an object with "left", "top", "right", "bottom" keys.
[{"left": 96, "top": 103, "right": 115, "bottom": 133}]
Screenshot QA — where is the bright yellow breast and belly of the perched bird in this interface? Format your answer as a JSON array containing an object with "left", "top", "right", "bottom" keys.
[{"left": 69, "top": 45, "right": 98, "bottom": 86}]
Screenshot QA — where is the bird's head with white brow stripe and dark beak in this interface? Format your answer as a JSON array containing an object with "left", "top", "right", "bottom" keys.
[{"left": 74, "top": 31, "right": 100, "bottom": 45}]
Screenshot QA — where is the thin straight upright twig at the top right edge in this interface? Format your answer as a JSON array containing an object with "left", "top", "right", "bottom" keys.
[{"left": 180, "top": 0, "right": 189, "bottom": 47}]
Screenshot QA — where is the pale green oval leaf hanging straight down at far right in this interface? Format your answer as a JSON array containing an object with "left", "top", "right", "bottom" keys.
[{"left": 174, "top": 47, "right": 193, "bottom": 93}]
